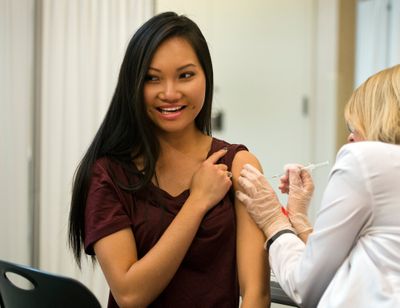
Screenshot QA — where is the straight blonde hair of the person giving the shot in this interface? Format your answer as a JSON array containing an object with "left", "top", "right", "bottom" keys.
[{"left": 344, "top": 65, "right": 400, "bottom": 144}]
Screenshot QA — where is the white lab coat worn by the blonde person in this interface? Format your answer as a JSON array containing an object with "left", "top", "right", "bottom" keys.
[{"left": 269, "top": 141, "right": 400, "bottom": 308}]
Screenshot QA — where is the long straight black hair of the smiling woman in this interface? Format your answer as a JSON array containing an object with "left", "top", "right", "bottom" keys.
[{"left": 69, "top": 12, "right": 213, "bottom": 266}]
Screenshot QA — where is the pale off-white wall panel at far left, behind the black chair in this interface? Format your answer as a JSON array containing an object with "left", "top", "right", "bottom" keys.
[{"left": 0, "top": 0, "right": 34, "bottom": 264}]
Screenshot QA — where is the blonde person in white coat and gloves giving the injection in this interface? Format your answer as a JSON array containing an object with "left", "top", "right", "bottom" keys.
[{"left": 236, "top": 65, "right": 400, "bottom": 308}]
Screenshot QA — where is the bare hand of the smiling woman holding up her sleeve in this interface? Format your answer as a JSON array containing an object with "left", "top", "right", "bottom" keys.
[{"left": 190, "top": 149, "right": 232, "bottom": 211}]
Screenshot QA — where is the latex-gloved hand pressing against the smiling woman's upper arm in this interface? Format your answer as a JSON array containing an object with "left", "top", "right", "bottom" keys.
[{"left": 236, "top": 164, "right": 293, "bottom": 240}]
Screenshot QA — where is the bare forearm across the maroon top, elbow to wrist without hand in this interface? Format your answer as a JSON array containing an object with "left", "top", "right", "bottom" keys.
[{"left": 96, "top": 197, "right": 206, "bottom": 307}]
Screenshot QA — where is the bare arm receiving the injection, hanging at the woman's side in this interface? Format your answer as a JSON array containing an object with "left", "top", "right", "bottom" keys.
[{"left": 232, "top": 151, "right": 270, "bottom": 308}]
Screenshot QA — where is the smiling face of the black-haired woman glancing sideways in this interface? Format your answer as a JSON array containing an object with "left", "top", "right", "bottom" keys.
[{"left": 144, "top": 37, "right": 206, "bottom": 133}]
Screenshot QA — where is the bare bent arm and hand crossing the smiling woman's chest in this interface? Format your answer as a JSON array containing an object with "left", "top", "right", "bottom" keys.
[{"left": 94, "top": 151, "right": 231, "bottom": 307}]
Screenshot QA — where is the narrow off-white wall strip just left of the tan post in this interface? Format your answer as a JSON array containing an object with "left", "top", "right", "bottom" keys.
[{"left": 309, "top": 0, "right": 339, "bottom": 220}]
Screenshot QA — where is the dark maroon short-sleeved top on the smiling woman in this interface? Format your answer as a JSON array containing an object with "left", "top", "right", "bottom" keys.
[{"left": 85, "top": 138, "right": 247, "bottom": 308}]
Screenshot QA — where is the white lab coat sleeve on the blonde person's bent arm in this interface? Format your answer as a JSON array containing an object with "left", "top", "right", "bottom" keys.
[{"left": 269, "top": 146, "right": 372, "bottom": 307}]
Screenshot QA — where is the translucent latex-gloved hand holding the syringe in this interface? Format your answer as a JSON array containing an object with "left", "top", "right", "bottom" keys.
[{"left": 281, "top": 165, "right": 314, "bottom": 234}]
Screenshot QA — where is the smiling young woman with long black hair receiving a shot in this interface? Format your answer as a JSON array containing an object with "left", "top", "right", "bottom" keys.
[{"left": 70, "top": 12, "right": 269, "bottom": 308}]
